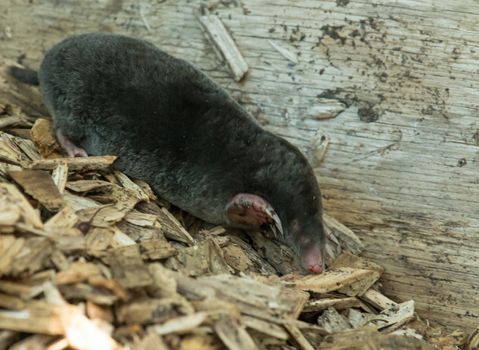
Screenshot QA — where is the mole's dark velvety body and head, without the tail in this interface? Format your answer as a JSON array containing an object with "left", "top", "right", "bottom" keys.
[{"left": 12, "top": 33, "right": 324, "bottom": 272}]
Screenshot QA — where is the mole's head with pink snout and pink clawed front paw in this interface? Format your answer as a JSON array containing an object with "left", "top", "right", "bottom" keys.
[{"left": 226, "top": 136, "right": 325, "bottom": 273}]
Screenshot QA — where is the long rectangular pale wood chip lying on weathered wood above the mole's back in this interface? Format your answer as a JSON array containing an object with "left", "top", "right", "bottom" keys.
[{"left": 199, "top": 14, "right": 248, "bottom": 81}]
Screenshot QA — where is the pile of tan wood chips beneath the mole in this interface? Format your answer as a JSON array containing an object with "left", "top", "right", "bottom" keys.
[{"left": 0, "top": 103, "right": 479, "bottom": 350}]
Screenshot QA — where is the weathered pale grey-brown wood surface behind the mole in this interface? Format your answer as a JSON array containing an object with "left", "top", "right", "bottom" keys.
[{"left": 0, "top": 0, "right": 479, "bottom": 328}]
